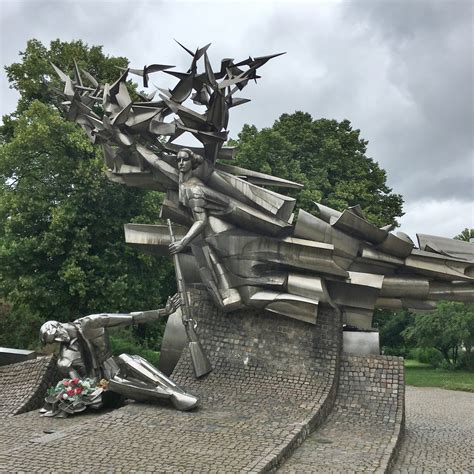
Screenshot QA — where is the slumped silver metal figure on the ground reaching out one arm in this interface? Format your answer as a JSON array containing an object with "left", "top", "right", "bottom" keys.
[{"left": 40, "top": 295, "right": 198, "bottom": 410}]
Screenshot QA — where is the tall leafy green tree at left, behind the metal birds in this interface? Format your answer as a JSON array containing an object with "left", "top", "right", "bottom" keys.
[{"left": 0, "top": 40, "right": 172, "bottom": 347}]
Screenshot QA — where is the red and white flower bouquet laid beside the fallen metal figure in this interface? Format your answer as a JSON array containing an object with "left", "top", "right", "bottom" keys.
[{"left": 40, "top": 377, "right": 107, "bottom": 418}]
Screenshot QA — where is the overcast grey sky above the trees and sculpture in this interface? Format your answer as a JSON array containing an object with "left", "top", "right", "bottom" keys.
[{"left": 0, "top": 0, "right": 474, "bottom": 243}]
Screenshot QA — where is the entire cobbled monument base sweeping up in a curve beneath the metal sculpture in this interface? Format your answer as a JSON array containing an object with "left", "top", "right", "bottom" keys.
[{"left": 0, "top": 292, "right": 404, "bottom": 473}]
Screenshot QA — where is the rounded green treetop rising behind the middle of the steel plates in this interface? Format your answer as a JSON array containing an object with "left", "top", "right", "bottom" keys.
[{"left": 232, "top": 112, "right": 403, "bottom": 226}]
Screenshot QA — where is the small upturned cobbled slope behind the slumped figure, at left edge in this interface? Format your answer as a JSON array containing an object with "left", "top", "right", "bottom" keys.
[{"left": 0, "top": 356, "right": 58, "bottom": 416}]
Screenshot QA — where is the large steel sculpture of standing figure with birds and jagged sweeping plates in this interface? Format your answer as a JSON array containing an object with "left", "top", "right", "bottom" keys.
[{"left": 47, "top": 41, "right": 474, "bottom": 386}]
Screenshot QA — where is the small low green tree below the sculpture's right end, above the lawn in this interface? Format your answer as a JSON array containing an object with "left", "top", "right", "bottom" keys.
[{"left": 402, "top": 301, "right": 474, "bottom": 367}]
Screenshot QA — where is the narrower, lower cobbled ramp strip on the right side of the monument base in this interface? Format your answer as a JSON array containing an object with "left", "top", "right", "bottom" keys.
[{"left": 278, "top": 356, "right": 404, "bottom": 474}]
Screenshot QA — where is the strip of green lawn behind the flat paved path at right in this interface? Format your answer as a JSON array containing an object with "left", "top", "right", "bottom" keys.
[{"left": 405, "top": 359, "right": 474, "bottom": 392}]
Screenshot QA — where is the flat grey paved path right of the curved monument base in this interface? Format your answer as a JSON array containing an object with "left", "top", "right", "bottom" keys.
[{"left": 393, "top": 387, "right": 474, "bottom": 474}]
